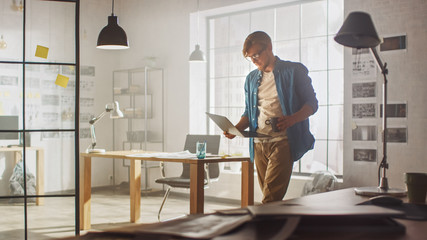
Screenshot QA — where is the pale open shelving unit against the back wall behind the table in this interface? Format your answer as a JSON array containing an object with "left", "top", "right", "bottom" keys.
[{"left": 113, "top": 66, "right": 164, "bottom": 190}]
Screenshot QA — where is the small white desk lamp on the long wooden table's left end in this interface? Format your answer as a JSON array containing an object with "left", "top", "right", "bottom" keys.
[{"left": 86, "top": 101, "right": 123, "bottom": 153}]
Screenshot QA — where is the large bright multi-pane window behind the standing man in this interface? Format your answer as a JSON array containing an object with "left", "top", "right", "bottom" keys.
[{"left": 202, "top": 0, "right": 344, "bottom": 175}]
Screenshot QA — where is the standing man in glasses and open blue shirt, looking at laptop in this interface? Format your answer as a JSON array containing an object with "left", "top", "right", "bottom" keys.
[{"left": 224, "top": 31, "right": 318, "bottom": 203}]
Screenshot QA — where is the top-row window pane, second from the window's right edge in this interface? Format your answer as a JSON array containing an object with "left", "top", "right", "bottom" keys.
[{"left": 301, "top": 1, "right": 327, "bottom": 38}]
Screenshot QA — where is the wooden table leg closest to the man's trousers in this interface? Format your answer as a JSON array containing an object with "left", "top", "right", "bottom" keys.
[{"left": 242, "top": 161, "right": 254, "bottom": 207}]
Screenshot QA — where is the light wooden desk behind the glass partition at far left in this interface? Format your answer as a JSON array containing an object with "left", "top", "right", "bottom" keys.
[{"left": 0, "top": 147, "right": 44, "bottom": 205}]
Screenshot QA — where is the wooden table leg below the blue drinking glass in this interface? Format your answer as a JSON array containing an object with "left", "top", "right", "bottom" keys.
[{"left": 190, "top": 161, "right": 205, "bottom": 214}]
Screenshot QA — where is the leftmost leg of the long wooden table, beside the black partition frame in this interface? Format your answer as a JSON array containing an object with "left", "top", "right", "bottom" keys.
[{"left": 79, "top": 157, "right": 92, "bottom": 230}]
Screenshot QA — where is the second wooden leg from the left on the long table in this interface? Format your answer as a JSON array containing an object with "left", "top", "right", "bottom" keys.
[{"left": 129, "top": 160, "right": 141, "bottom": 223}]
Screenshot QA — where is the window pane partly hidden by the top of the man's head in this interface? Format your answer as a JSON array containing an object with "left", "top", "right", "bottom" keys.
[{"left": 229, "top": 13, "right": 250, "bottom": 47}]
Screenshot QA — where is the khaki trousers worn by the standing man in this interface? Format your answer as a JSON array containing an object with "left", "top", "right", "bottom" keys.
[{"left": 254, "top": 139, "right": 293, "bottom": 203}]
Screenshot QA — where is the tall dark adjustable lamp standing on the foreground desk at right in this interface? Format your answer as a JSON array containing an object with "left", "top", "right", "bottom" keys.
[{"left": 334, "top": 12, "right": 406, "bottom": 196}]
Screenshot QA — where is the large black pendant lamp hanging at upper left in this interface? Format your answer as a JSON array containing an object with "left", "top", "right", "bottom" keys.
[{"left": 96, "top": 0, "right": 129, "bottom": 50}]
